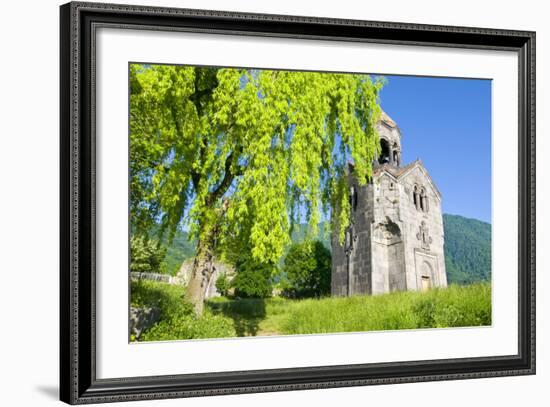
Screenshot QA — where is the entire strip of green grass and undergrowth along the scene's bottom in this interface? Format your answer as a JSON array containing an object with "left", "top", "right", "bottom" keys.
[{"left": 132, "top": 281, "right": 491, "bottom": 341}]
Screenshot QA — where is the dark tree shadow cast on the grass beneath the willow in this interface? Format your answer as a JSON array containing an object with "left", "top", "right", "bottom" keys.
[{"left": 208, "top": 298, "right": 266, "bottom": 336}]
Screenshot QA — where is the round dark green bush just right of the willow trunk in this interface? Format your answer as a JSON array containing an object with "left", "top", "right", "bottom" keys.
[{"left": 231, "top": 257, "right": 277, "bottom": 298}]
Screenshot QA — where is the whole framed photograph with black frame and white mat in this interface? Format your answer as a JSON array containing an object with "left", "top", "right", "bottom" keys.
[{"left": 60, "top": 2, "right": 535, "bottom": 404}]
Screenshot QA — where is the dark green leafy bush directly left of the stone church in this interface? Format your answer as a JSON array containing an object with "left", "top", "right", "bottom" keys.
[{"left": 283, "top": 240, "right": 331, "bottom": 297}]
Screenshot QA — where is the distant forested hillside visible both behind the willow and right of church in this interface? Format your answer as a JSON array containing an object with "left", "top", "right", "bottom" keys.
[{"left": 157, "top": 215, "right": 491, "bottom": 284}]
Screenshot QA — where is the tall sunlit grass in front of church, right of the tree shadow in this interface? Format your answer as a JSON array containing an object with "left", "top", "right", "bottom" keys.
[{"left": 282, "top": 283, "right": 491, "bottom": 334}]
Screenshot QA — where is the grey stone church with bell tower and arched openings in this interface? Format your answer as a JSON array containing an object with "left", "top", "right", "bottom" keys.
[{"left": 331, "top": 112, "right": 447, "bottom": 296}]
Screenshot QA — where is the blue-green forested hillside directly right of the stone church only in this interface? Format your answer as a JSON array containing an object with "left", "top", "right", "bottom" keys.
[{"left": 443, "top": 215, "right": 491, "bottom": 284}]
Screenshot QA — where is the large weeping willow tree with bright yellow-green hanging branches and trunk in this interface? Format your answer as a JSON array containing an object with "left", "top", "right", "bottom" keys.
[{"left": 130, "top": 64, "right": 382, "bottom": 314}]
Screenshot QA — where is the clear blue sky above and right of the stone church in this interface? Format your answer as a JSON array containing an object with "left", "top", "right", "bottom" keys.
[{"left": 380, "top": 75, "right": 491, "bottom": 222}]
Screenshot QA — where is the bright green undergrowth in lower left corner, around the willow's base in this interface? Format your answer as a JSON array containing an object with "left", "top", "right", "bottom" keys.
[{"left": 131, "top": 281, "right": 236, "bottom": 341}]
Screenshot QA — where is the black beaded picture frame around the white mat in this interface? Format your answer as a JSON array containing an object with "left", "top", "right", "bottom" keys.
[{"left": 60, "top": 2, "right": 535, "bottom": 404}]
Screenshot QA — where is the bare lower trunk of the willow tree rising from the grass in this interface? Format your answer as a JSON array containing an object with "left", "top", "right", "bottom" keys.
[{"left": 186, "top": 240, "right": 213, "bottom": 316}]
